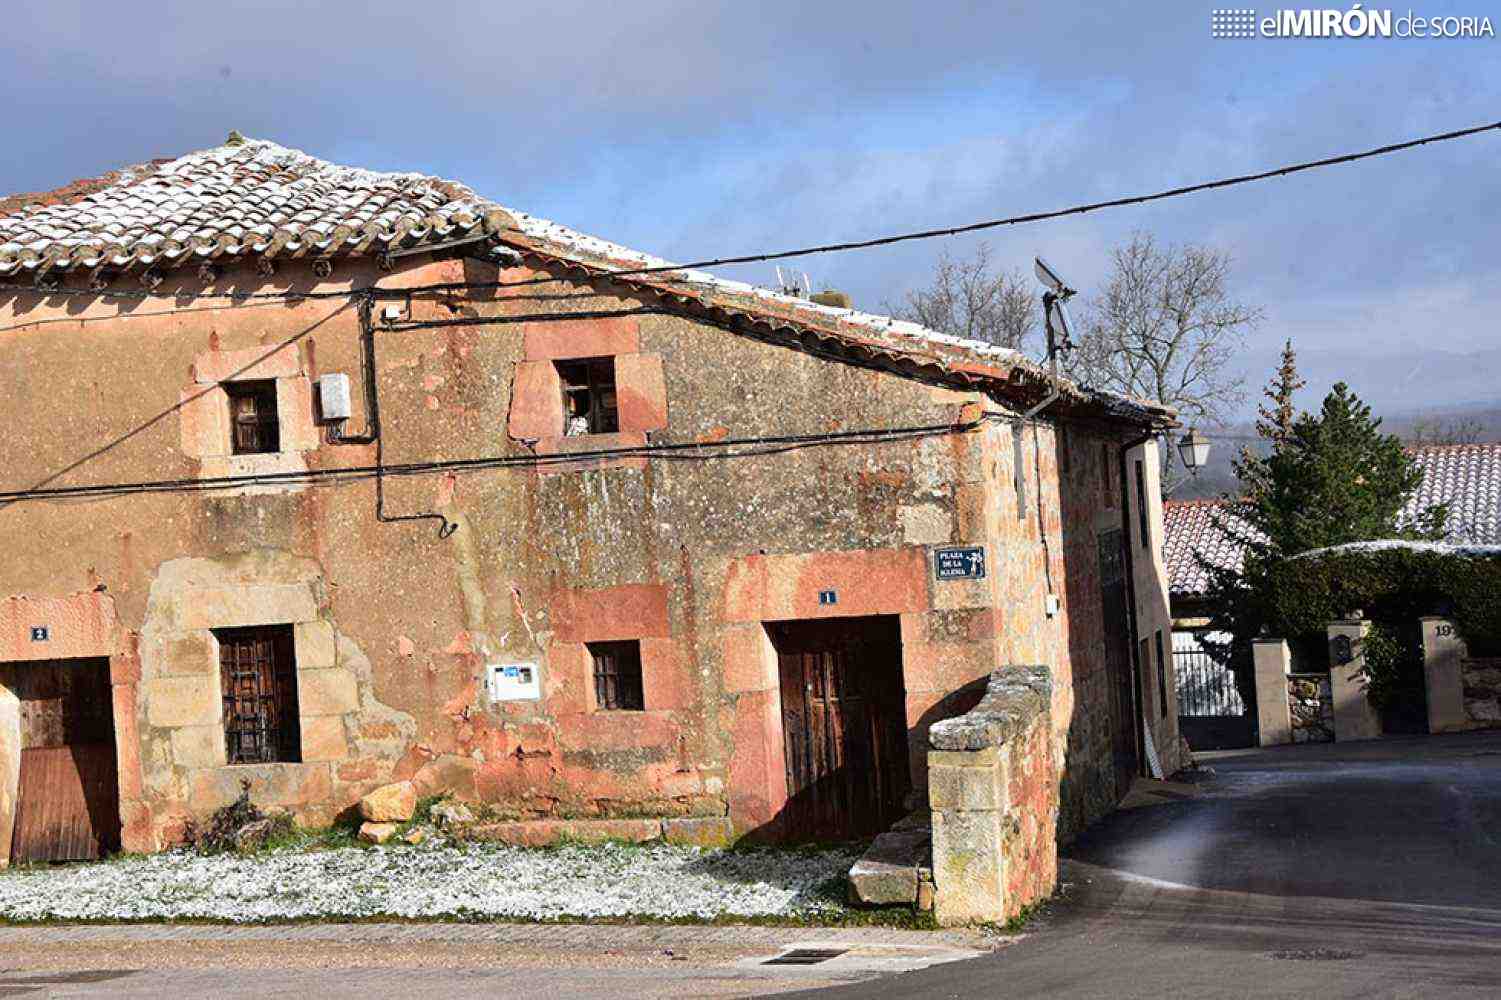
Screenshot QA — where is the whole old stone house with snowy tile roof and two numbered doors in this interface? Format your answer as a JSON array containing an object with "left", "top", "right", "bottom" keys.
[{"left": 0, "top": 135, "right": 1178, "bottom": 863}]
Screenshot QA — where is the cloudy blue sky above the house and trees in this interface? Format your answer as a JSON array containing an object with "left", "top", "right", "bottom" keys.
[{"left": 0, "top": 0, "right": 1501, "bottom": 407}]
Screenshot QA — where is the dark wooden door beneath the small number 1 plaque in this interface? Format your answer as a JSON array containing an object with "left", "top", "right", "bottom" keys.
[{"left": 772, "top": 617, "right": 911, "bottom": 841}]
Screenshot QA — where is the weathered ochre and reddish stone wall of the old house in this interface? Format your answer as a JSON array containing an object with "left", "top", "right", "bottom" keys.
[{"left": 0, "top": 260, "right": 1158, "bottom": 850}]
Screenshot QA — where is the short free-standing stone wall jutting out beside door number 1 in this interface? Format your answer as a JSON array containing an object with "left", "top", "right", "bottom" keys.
[{"left": 928, "top": 667, "right": 1058, "bottom": 925}]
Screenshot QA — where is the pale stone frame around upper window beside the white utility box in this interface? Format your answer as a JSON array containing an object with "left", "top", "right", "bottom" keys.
[{"left": 179, "top": 344, "right": 320, "bottom": 494}]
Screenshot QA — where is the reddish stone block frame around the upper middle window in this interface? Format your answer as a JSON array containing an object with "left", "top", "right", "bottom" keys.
[{"left": 506, "top": 315, "right": 668, "bottom": 471}]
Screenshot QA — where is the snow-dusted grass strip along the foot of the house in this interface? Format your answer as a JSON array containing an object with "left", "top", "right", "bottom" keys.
[{"left": 0, "top": 842, "right": 856, "bottom": 923}]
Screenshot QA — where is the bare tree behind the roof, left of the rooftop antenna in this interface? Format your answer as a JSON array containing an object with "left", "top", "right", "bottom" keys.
[{"left": 883, "top": 243, "right": 1042, "bottom": 350}]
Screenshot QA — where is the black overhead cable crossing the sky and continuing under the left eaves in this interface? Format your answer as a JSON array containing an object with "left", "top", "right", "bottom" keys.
[{"left": 0, "top": 122, "right": 1501, "bottom": 300}]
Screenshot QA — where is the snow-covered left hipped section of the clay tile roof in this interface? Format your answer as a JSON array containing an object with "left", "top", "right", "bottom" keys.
[{"left": 0, "top": 140, "right": 498, "bottom": 275}]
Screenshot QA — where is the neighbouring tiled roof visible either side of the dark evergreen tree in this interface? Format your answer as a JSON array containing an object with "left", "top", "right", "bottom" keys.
[{"left": 1162, "top": 443, "right": 1501, "bottom": 598}]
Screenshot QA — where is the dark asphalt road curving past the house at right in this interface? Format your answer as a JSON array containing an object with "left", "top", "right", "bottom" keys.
[{"left": 806, "top": 733, "right": 1501, "bottom": 1000}]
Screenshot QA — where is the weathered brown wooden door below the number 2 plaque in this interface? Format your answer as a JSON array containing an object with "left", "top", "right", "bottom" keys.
[{"left": 11, "top": 659, "right": 120, "bottom": 863}]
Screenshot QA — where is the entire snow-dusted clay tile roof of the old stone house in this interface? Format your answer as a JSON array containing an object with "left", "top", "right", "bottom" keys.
[{"left": 0, "top": 135, "right": 1177, "bottom": 426}]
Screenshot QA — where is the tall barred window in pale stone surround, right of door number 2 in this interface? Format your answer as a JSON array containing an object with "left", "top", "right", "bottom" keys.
[{"left": 215, "top": 625, "right": 302, "bottom": 764}]
